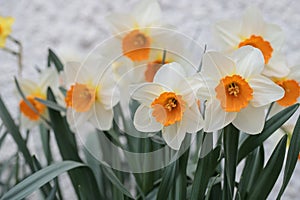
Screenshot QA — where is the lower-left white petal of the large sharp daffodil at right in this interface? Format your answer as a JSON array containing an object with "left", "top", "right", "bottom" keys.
[{"left": 204, "top": 99, "right": 236, "bottom": 132}]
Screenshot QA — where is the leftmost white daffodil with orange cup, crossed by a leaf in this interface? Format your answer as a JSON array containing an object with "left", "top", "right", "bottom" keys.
[{"left": 18, "top": 68, "right": 58, "bottom": 129}]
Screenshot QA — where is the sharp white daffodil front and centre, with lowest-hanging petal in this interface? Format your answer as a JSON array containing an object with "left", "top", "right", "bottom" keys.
[{"left": 132, "top": 63, "right": 203, "bottom": 150}]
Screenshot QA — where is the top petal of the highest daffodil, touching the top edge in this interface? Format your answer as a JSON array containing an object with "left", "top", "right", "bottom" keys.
[{"left": 133, "top": 0, "right": 162, "bottom": 27}]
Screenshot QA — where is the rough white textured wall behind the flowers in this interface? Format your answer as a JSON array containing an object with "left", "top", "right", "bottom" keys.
[{"left": 0, "top": 0, "right": 300, "bottom": 199}]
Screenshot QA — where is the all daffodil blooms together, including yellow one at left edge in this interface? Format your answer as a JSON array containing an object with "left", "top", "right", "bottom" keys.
[{"left": 12, "top": 0, "right": 300, "bottom": 150}]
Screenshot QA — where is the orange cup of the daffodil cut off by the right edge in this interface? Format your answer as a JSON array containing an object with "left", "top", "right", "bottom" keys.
[{"left": 276, "top": 80, "right": 300, "bottom": 106}]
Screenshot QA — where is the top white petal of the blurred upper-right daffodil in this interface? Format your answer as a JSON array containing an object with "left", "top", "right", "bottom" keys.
[{"left": 241, "top": 6, "right": 265, "bottom": 37}]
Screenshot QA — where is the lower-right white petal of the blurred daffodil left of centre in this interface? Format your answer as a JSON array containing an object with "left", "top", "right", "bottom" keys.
[{"left": 90, "top": 102, "right": 113, "bottom": 131}]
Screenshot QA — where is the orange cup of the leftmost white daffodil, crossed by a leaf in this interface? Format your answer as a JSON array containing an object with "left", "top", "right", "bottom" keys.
[{"left": 19, "top": 95, "right": 46, "bottom": 121}]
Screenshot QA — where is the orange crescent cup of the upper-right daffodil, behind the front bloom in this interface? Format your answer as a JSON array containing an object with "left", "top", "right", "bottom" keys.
[{"left": 239, "top": 35, "right": 273, "bottom": 64}]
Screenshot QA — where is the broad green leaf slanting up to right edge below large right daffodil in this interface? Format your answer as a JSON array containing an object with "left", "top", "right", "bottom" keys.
[{"left": 238, "top": 104, "right": 299, "bottom": 163}]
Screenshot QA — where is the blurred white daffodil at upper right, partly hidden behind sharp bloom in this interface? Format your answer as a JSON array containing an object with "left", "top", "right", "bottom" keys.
[{"left": 214, "top": 7, "right": 289, "bottom": 77}]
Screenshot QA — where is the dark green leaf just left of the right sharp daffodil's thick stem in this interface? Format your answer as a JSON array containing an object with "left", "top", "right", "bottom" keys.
[{"left": 191, "top": 146, "right": 221, "bottom": 200}]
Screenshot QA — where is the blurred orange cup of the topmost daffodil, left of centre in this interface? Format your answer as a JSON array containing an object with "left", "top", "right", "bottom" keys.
[{"left": 122, "top": 30, "right": 151, "bottom": 61}]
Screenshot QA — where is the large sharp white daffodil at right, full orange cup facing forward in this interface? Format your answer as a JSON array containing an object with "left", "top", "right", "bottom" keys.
[{"left": 199, "top": 46, "right": 284, "bottom": 134}]
